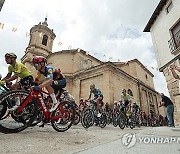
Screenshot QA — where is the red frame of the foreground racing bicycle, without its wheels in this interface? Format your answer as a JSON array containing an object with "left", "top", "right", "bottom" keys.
[{"left": 17, "top": 90, "right": 69, "bottom": 120}]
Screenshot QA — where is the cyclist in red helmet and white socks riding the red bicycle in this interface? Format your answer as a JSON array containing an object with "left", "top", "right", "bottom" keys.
[{"left": 32, "top": 56, "right": 66, "bottom": 112}]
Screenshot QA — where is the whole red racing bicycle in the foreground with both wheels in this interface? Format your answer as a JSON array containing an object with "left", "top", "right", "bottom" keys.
[{"left": 0, "top": 86, "right": 75, "bottom": 133}]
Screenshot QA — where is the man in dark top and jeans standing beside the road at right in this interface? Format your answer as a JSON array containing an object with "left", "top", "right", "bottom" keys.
[{"left": 159, "top": 93, "right": 174, "bottom": 127}]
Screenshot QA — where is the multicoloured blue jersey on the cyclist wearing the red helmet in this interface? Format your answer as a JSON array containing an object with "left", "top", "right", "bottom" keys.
[{"left": 36, "top": 66, "right": 65, "bottom": 81}]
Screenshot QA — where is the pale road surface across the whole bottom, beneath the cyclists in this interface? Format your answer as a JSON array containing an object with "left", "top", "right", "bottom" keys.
[{"left": 0, "top": 124, "right": 180, "bottom": 154}]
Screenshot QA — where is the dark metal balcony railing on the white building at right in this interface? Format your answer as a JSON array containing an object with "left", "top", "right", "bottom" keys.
[{"left": 168, "top": 30, "right": 180, "bottom": 52}]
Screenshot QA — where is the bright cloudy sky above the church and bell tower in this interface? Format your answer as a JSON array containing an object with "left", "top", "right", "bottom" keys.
[{"left": 0, "top": 0, "right": 169, "bottom": 95}]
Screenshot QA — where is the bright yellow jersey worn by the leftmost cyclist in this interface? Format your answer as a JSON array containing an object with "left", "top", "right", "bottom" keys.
[{"left": 8, "top": 62, "right": 32, "bottom": 79}]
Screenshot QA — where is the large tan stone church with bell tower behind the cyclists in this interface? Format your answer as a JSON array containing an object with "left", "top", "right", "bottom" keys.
[{"left": 21, "top": 18, "right": 164, "bottom": 114}]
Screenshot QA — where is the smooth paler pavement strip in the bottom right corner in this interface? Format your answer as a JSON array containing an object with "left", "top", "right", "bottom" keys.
[{"left": 78, "top": 126, "right": 180, "bottom": 154}]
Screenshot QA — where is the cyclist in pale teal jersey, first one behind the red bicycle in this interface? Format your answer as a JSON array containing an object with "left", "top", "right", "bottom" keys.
[{"left": 89, "top": 84, "right": 103, "bottom": 117}]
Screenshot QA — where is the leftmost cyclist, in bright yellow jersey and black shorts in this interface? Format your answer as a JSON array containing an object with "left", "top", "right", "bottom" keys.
[{"left": 2, "top": 53, "right": 33, "bottom": 111}]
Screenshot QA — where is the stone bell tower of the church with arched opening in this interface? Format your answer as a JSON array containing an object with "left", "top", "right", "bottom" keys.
[{"left": 21, "top": 17, "right": 56, "bottom": 75}]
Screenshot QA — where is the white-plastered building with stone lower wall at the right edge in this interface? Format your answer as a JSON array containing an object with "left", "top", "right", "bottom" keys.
[{"left": 144, "top": 0, "right": 180, "bottom": 124}]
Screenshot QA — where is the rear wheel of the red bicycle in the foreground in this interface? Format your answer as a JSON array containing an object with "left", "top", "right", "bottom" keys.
[{"left": 51, "top": 101, "right": 75, "bottom": 132}]
